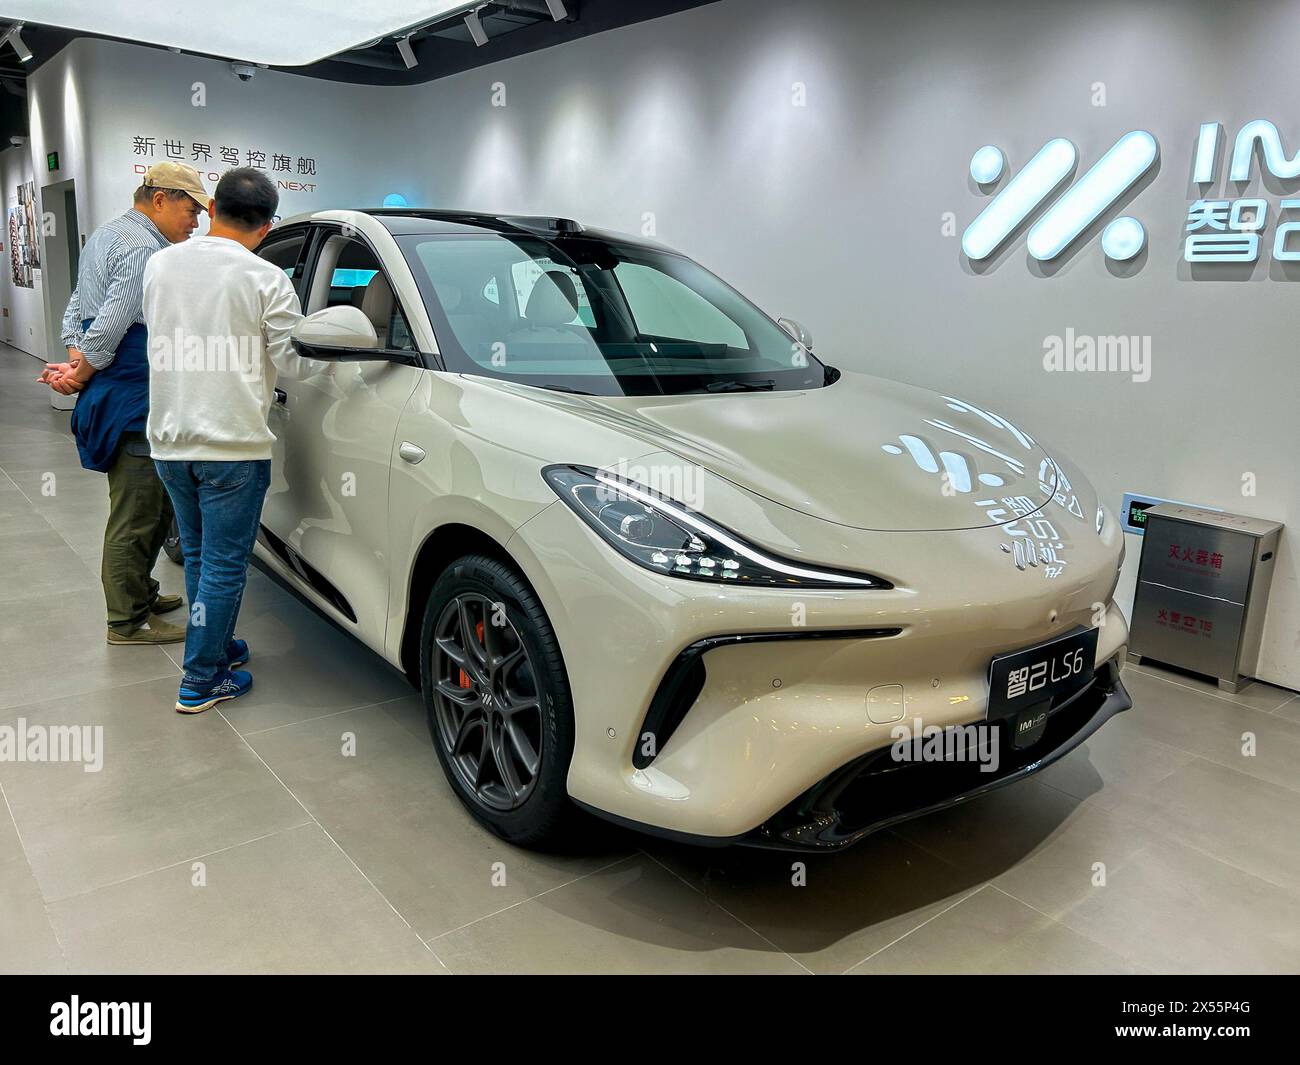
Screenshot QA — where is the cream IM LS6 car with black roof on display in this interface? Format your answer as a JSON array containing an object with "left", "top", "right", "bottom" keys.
[{"left": 250, "top": 209, "right": 1130, "bottom": 849}]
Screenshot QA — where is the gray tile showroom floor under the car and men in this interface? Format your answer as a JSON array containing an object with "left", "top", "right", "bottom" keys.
[{"left": 0, "top": 346, "right": 1300, "bottom": 973}]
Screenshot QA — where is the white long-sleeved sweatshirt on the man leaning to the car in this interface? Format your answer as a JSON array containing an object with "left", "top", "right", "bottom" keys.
[{"left": 144, "top": 237, "right": 326, "bottom": 462}]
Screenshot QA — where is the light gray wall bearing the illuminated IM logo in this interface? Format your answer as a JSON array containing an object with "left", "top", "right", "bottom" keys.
[{"left": 392, "top": 0, "right": 1300, "bottom": 688}]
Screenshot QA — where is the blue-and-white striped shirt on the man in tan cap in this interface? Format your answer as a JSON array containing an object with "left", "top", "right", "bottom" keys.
[{"left": 61, "top": 208, "right": 170, "bottom": 369}]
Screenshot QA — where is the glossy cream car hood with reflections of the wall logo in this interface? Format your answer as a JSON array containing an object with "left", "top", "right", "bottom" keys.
[{"left": 532, "top": 373, "right": 1058, "bottom": 532}]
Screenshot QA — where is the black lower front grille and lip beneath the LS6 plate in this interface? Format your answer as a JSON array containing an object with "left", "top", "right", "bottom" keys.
[{"left": 742, "top": 661, "right": 1132, "bottom": 850}]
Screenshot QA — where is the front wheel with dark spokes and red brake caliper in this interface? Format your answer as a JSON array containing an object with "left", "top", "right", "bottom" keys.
[{"left": 420, "top": 555, "right": 576, "bottom": 847}]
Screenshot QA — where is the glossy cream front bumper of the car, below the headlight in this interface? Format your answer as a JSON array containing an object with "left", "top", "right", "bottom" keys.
[{"left": 507, "top": 486, "right": 1128, "bottom": 844}]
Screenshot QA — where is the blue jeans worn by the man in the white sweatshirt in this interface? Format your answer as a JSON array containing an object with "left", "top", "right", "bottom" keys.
[{"left": 153, "top": 459, "right": 270, "bottom": 685}]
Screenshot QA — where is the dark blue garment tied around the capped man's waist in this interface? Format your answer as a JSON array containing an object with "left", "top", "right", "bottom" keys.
[{"left": 72, "top": 319, "right": 150, "bottom": 473}]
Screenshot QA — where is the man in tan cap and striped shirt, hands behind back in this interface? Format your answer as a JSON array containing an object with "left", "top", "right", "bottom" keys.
[{"left": 40, "top": 163, "right": 208, "bottom": 644}]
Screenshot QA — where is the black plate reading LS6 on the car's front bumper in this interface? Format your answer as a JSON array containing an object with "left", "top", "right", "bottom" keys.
[{"left": 988, "top": 628, "right": 1097, "bottom": 746}]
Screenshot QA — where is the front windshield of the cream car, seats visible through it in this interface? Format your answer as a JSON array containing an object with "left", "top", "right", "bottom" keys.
[{"left": 399, "top": 233, "right": 827, "bottom": 395}]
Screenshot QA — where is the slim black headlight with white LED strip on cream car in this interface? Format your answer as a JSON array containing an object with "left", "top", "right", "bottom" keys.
[{"left": 542, "top": 466, "right": 893, "bottom": 589}]
